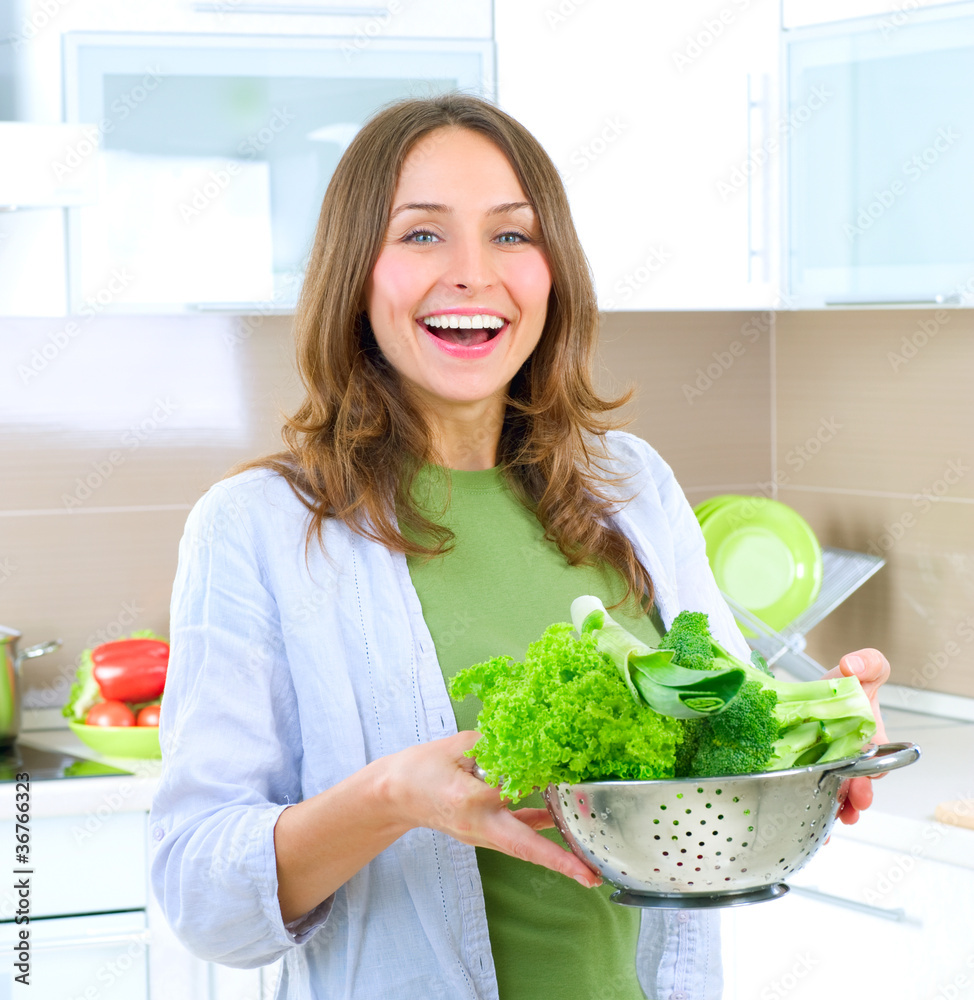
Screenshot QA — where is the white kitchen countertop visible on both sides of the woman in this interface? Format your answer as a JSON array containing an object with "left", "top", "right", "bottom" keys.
[{"left": 0, "top": 708, "right": 974, "bottom": 868}]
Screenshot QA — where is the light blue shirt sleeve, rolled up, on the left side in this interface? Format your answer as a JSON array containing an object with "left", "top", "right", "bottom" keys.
[{"left": 150, "top": 484, "right": 331, "bottom": 968}]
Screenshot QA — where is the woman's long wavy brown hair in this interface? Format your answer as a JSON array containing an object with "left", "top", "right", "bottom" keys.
[{"left": 244, "top": 93, "right": 653, "bottom": 601}]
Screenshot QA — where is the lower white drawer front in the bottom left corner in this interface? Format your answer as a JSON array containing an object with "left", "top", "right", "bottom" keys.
[{"left": 0, "top": 913, "right": 149, "bottom": 1000}]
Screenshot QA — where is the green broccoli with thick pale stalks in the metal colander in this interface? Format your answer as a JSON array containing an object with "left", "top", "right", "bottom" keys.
[{"left": 660, "top": 611, "right": 876, "bottom": 778}]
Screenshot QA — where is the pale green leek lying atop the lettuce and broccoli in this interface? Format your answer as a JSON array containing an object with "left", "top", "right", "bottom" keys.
[{"left": 572, "top": 595, "right": 744, "bottom": 719}]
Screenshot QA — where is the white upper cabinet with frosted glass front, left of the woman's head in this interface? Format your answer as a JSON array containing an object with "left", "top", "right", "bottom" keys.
[{"left": 0, "top": 0, "right": 494, "bottom": 318}]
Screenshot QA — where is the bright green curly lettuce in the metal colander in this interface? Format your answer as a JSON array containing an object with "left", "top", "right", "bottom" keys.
[{"left": 449, "top": 623, "right": 681, "bottom": 802}]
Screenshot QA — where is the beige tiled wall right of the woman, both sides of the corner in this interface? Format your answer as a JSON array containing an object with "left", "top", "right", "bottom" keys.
[{"left": 604, "top": 310, "right": 974, "bottom": 697}]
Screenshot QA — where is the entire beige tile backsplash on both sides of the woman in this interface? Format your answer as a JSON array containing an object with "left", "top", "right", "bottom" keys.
[{"left": 0, "top": 310, "right": 974, "bottom": 706}]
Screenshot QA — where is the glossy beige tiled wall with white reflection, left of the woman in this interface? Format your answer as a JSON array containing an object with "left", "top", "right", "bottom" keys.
[{"left": 0, "top": 316, "right": 299, "bottom": 708}]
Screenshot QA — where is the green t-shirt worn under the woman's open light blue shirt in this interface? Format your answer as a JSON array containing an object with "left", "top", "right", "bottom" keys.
[{"left": 407, "top": 466, "right": 661, "bottom": 1000}]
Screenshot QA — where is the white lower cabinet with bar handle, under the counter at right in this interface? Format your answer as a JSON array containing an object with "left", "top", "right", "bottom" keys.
[{"left": 722, "top": 823, "right": 974, "bottom": 1000}]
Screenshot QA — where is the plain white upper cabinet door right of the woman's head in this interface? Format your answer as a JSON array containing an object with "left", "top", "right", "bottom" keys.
[{"left": 495, "top": 0, "right": 787, "bottom": 309}]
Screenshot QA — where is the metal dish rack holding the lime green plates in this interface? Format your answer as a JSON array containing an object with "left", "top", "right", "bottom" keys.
[{"left": 723, "top": 547, "right": 886, "bottom": 681}]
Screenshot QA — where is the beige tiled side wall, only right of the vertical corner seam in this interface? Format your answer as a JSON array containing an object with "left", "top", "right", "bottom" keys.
[{"left": 775, "top": 310, "right": 974, "bottom": 697}]
